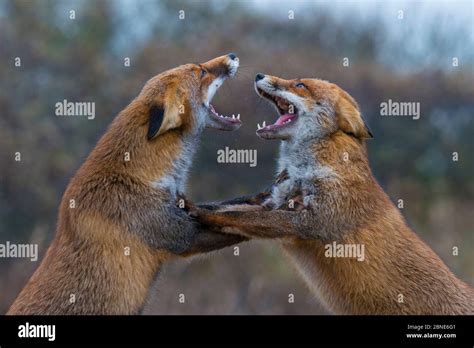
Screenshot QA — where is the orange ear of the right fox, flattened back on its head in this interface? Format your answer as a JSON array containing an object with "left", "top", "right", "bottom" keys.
[{"left": 336, "top": 95, "right": 373, "bottom": 139}]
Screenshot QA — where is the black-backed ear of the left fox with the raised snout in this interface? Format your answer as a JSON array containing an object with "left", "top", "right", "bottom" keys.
[{"left": 148, "top": 103, "right": 182, "bottom": 140}]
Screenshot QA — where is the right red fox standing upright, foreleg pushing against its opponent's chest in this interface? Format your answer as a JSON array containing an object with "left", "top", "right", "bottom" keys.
[{"left": 192, "top": 74, "right": 474, "bottom": 315}]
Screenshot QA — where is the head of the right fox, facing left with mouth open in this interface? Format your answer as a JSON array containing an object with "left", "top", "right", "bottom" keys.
[{"left": 255, "top": 74, "right": 372, "bottom": 140}]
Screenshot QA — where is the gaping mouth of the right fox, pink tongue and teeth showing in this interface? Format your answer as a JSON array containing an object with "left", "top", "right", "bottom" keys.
[{"left": 257, "top": 87, "right": 298, "bottom": 135}]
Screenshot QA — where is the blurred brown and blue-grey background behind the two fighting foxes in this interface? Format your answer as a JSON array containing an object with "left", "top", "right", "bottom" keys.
[{"left": 0, "top": 0, "right": 474, "bottom": 314}]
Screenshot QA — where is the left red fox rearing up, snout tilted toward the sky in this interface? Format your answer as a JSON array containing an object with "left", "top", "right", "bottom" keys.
[{"left": 7, "top": 53, "right": 244, "bottom": 315}]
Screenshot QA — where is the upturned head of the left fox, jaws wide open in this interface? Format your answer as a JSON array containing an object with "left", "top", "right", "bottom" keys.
[{"left": 138, "top": 53, "right": 241, "bottom": 141}]
